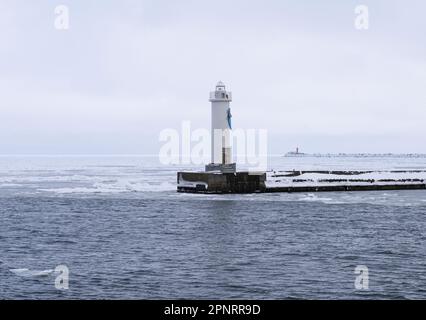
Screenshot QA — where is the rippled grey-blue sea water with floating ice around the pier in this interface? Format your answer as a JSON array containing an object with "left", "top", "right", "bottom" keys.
[{"left": 0, "top": 156, "right": 426, "bottom": 299}]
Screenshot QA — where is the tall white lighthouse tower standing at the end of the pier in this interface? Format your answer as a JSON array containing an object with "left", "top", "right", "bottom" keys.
[{"left": 206, "top": 81, "right": 236, "bottom": 173}]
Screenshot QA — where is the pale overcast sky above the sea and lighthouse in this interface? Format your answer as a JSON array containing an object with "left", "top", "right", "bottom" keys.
[{"left": 0, "top": 0, "right": 426, "bottom": 154}]
